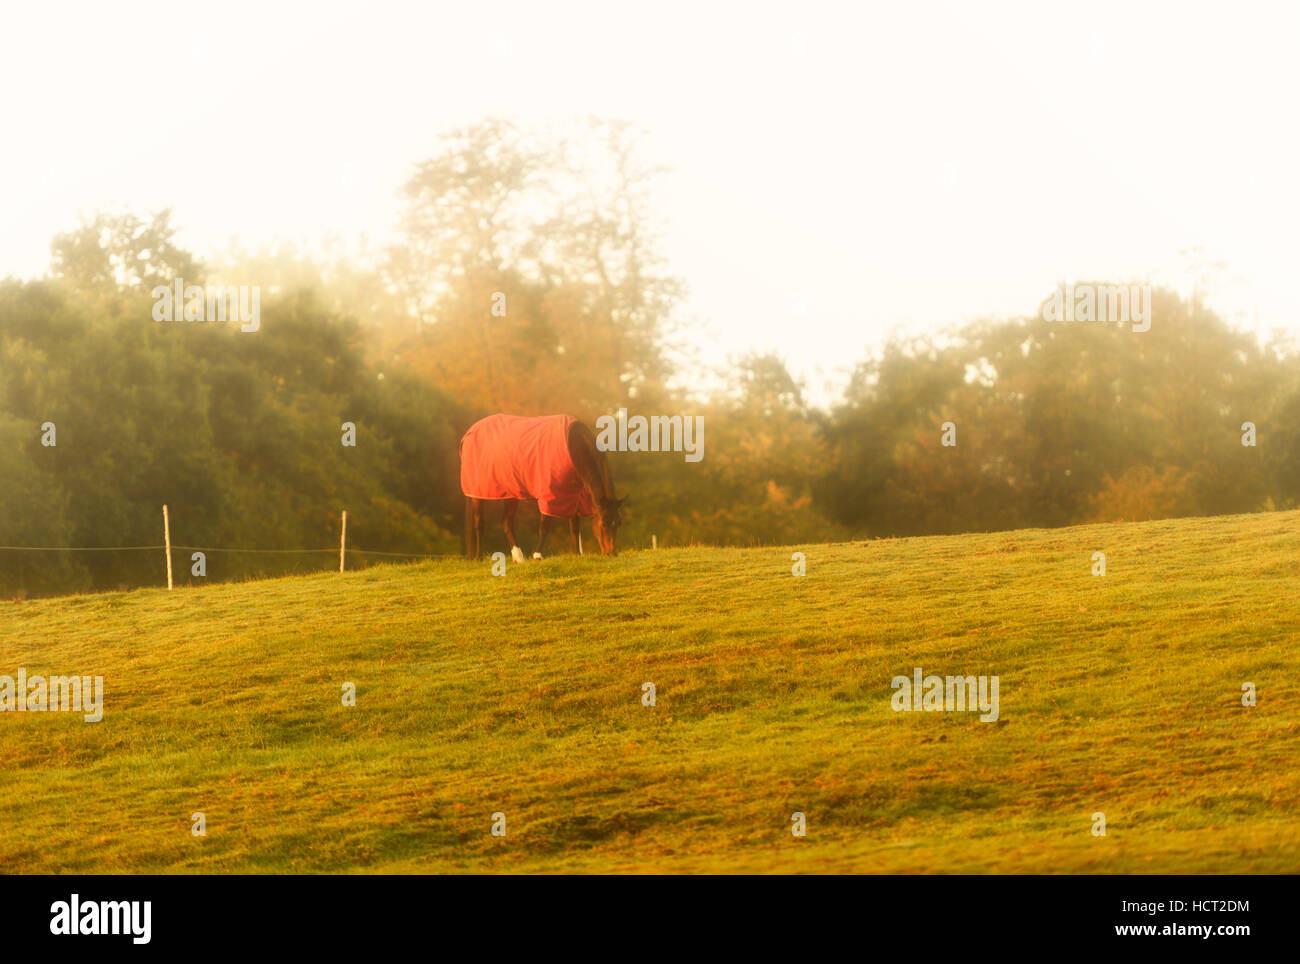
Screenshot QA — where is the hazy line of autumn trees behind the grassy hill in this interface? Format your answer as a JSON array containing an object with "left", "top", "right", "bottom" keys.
[{"left": 0, "top": 121, "right": 1300, "bottom": 592}]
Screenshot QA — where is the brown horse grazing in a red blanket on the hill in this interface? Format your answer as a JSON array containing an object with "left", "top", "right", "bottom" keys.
[{"left": 460, "top": 414, "right": 625, "bottom": 563}]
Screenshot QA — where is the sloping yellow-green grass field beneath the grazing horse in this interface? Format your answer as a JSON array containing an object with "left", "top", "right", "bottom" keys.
[{"left": 0, "top": 512, "right": 1300, "bottom": 873}]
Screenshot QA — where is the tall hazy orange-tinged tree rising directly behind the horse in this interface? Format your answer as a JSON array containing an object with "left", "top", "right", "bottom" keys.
[{"left": 389, "top": 121, "right": 683, "bottom": 417}]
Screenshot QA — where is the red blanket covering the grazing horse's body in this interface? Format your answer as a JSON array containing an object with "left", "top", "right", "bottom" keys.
[{"left": 460, "top": 414, "right": 593, "bottom": 518}]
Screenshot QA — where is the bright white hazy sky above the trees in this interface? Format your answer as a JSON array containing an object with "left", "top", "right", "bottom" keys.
[{"left": 0, "top": 0, "right": 1300, "bottom": 396}]
